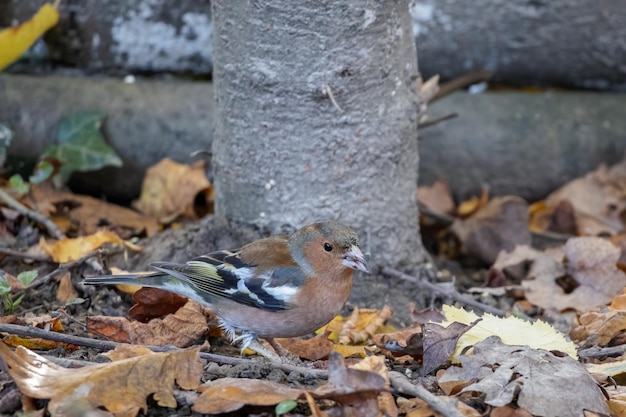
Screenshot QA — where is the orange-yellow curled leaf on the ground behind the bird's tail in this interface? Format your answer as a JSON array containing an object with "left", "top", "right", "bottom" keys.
[{"left": 39, "top": 230, "right": 136, "bottom": 263}]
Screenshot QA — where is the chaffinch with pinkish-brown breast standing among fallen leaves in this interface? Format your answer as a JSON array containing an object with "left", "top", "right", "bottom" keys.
[{"left": 84, "top": 221, "right": 367, "bottom": 359}]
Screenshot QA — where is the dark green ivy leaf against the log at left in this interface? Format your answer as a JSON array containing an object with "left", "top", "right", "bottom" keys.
[{"left": 43, "top": 111, "right": 122, "bottom": 183}]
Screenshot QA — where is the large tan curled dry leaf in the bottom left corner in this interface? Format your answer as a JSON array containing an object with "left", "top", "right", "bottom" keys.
[{"left": 0, "top": 344, "right": 203, "bottom": 416}]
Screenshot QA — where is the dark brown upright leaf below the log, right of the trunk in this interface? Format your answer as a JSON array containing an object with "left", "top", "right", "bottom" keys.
[{"left": 451, "top": 196, "right": 530, "bottom": 264}]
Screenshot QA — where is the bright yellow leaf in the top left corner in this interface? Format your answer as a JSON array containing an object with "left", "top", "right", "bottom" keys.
[{"left": 0, "top": 3, "right": 59, "bottom": 71}]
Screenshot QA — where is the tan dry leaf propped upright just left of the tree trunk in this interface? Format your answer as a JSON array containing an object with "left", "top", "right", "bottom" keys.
[{"left": 133, "top": 158, "right": 213, "bottom": 223}]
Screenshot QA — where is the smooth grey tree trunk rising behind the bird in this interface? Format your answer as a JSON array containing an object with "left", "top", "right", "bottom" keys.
[{"left": 212, "top": 0, "right": 421, "bottom": 267}]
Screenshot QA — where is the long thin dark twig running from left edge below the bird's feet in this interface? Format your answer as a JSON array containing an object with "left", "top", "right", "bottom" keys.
[{"left": 0, "top": 324, "right": 328, "bottom": 379}]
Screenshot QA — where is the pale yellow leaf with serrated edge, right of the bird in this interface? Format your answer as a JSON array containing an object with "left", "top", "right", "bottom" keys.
[{"left": 439, "top": 305, "right": 578, "bottom": 362}]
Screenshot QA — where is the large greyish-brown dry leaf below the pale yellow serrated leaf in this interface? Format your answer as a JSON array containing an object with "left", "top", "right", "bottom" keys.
[{"left": 440, "top": 336, "right": 609, "bottom": 416}]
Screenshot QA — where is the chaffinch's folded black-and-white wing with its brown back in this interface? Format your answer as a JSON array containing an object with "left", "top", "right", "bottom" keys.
[{"left": 151, "top": 238, "right": 305, "bottom": 311}]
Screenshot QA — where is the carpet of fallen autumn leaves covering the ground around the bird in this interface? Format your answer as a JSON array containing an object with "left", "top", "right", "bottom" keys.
[{"left": 0, "top": 154, "right": 626, "bottom": 416}]
